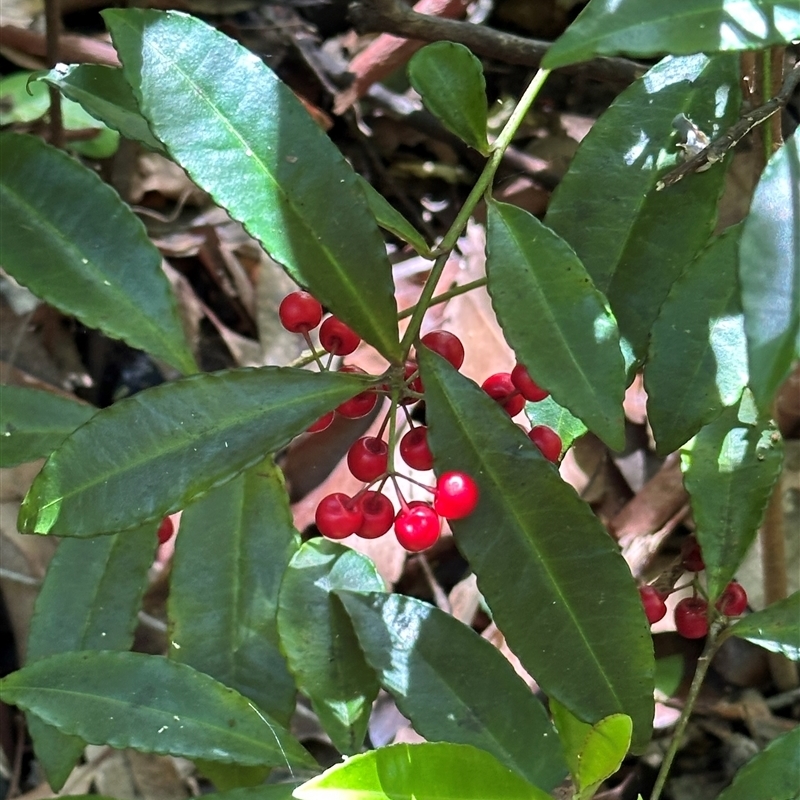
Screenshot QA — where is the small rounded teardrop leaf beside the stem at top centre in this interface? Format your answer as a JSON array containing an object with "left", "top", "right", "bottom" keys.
[{"left": 408, "top": 42, "right": 489, "bottom": 155}]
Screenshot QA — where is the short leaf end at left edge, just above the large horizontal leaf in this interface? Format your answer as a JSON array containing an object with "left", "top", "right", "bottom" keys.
[{"left": 0, "top": 386, "right": 97, "bottom": 467}]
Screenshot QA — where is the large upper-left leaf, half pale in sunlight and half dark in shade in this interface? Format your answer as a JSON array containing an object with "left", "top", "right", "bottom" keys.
[{"left": 103, "top": 9, "right": 400, "bottom": 361}]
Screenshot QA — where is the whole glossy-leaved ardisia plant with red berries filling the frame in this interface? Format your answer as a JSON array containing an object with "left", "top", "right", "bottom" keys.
[{"left": 0, "top": 0, "right": 800, "bottom": 800}]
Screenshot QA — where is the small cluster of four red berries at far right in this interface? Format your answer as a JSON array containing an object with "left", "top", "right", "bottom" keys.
[{"left": 639, "top": 536, "right": 747, "bottom": 639}]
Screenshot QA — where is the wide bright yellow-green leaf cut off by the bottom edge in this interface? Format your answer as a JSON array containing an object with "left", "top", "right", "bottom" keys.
[{"left": 294, "top": 743, "right": 550, "bottom": 800}]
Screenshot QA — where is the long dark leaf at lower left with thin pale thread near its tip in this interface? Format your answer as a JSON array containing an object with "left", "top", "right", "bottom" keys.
[{"left": 0, "top": 651, "right": 314, "bottom": 766}]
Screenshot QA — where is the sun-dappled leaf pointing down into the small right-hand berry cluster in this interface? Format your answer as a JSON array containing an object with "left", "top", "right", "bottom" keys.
[{"left": 681, "top": 395, "right": 783, "bottom": 600}]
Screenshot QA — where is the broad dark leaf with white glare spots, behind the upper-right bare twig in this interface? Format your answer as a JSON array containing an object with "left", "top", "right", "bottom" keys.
[{"left": 545, "top": 56, "right": 739, "bottom": 360}]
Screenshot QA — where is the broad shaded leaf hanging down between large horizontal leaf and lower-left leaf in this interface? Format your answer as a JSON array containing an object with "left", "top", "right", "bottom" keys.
[{"left": 168, "top": 459, "right": 300, "bottom": 725}]
